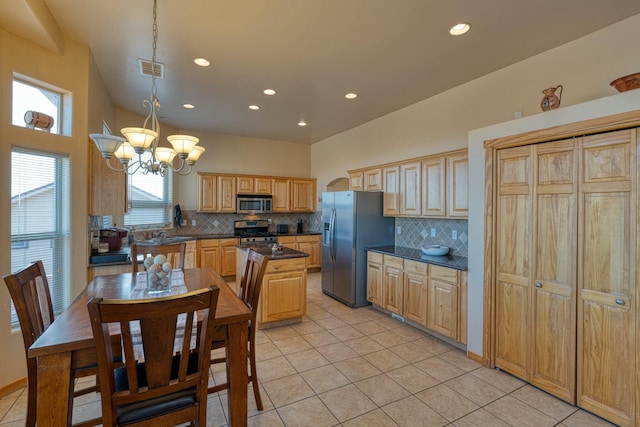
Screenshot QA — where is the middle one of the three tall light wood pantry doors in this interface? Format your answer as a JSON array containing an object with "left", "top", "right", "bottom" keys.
[{"left": 530, "top": 139, "right": 579, "bottom": 403}]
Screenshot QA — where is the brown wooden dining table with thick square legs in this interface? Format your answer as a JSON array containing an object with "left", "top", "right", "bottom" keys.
[{"left": 29, "top": 268, "right": 251, "bottom": 427}]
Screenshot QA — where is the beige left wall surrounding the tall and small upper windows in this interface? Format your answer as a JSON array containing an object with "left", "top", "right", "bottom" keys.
[{"left": 0, "top": 30, "right": 89, "bottom": 387}]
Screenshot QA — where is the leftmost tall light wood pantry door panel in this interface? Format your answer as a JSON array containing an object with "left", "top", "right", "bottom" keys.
[{"left": 495, "top": 146, "right": 533, "bottom": 381}]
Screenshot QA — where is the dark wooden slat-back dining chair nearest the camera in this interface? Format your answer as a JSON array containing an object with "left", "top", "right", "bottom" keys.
[{"left": 87, "top": 285, "right": 220, "bottom": 427}]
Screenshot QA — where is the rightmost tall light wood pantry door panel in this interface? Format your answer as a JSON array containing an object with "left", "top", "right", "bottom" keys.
[{"left": 578, "top": 129, "right": 639, "bottom": 426}]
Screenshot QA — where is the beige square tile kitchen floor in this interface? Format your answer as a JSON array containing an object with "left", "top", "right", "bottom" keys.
[{"left": 0, "top": 273, "right": 612, "bottom": 427}]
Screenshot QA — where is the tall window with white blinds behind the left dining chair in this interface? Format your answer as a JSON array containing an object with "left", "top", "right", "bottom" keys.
[{"left": 11, "top": 148, "right": 71, "bottom": 327}]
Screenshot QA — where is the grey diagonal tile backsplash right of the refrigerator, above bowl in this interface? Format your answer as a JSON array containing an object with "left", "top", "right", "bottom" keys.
[{"left": 396, "top": 218, "right": 469, "bottom": 257}]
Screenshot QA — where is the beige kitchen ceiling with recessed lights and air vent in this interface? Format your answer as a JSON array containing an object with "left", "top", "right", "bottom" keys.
[{"left": 5, "top": 0, "right": 640, "bottom": 143}]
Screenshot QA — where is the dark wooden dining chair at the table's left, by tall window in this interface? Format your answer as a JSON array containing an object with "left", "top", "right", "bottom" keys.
[{"left": 3, "top": 261, "right": 101, "bottom": 427}]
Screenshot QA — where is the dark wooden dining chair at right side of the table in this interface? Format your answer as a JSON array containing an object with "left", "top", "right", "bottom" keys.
[{"left": 209, "top": 249, "right": 269, "bottom": 411}]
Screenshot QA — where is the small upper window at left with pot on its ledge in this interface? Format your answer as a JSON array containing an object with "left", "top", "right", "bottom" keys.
[{"left": 11, "top": 79, "right": 62, "bottom": 134}]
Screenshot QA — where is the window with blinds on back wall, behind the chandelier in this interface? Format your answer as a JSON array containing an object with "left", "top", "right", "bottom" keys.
[{"left": 124, "top": 152, "right": 173, "bottom": 228}]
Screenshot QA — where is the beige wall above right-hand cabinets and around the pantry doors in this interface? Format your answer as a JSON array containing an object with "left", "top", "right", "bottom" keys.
[{"left": 311, "top": 15, "right": 640, "bottom": 355}]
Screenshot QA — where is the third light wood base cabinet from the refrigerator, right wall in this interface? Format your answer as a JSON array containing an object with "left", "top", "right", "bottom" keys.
[{"left": 403, "top": 259, "right": 428, "bottom": 326}]
